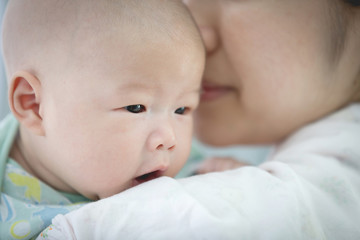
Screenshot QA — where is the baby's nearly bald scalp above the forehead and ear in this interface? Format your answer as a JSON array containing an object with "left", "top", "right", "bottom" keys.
[{"left": 3, "top": 0, "right": 201, "bottom": 79}]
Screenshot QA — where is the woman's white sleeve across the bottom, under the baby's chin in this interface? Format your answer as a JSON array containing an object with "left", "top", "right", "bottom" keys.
[{"left": 38, "top": 162, "right": 360, "bottom": 239}]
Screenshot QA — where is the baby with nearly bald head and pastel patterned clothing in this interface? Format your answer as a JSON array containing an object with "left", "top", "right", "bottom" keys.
[{"left": 0, "top": 0, "right": 205, "bottom": 239}]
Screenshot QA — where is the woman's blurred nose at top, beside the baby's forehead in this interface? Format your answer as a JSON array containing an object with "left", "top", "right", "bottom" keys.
[{"left": 183, "top": 0, "right": 218, "bottom": 55}]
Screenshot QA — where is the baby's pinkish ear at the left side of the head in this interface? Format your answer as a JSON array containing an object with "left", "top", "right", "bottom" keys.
[{"left": 8, "top": 71, "right": 45, "bottom": 136}]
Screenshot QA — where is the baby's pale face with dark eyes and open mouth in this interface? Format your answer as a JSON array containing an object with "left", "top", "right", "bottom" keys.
[{"left": 42, "top": 33, "right": 204, "bottom": 199}]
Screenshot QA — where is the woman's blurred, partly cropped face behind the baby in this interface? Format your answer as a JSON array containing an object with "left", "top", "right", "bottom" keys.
[{"left": 184, "top": 0, "right": 360, "bottom": 145}]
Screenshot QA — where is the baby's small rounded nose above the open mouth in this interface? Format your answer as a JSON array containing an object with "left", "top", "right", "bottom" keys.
[{"left": 147, "top": 124, "right": 176, "bottom": 152}]
